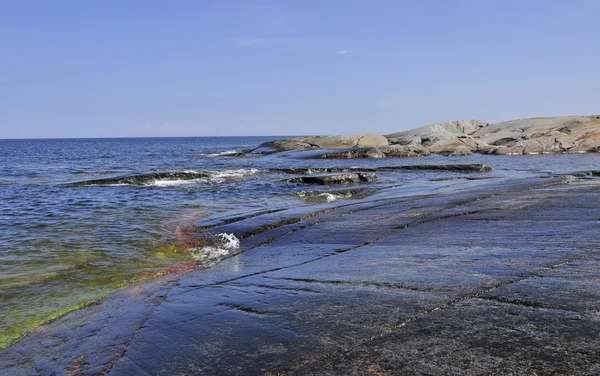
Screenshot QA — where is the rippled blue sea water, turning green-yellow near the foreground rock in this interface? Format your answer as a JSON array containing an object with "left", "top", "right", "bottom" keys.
[{"left": 0, "top": 137, "right": 600, "bottom": 348}]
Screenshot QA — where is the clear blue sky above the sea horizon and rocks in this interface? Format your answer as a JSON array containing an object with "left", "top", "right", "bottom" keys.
[{"left": 0, "top": 0, "right": 600, "bottom": 138}]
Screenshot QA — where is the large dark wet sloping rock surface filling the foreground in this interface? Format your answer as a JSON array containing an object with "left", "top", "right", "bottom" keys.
[{"left": 0, "top": 179, "right": 600, "bottom": 375}]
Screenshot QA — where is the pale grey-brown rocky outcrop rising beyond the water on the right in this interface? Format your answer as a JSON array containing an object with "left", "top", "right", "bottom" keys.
[{"left": 250, "top": 115, "right": 600, "bottom": 158}]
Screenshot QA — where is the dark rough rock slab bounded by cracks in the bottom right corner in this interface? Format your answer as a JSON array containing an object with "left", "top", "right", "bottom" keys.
[{"left": 294, "top": 298, "right": 600, "bottom": 375}]
